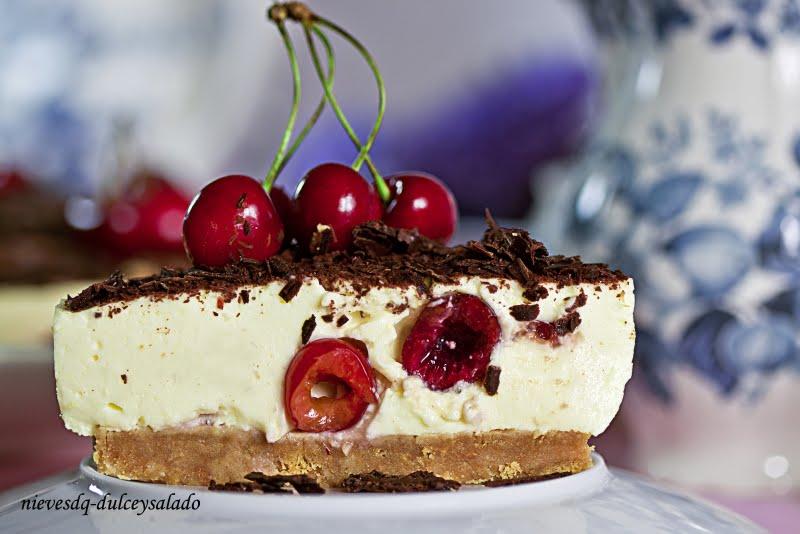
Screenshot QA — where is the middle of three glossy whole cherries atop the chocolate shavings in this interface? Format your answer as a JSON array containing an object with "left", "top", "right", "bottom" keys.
[{"left": 295, "top": 163, "right": 383, "bottom": 250}]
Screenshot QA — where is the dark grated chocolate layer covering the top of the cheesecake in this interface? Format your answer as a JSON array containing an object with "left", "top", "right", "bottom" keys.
[{"left": 65, "top": 218, "right": 627, "bottom": 311}]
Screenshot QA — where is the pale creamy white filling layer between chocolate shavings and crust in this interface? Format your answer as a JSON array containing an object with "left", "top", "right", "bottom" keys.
[{"left": 53, "top": 277, "right": 634, "bottom": 441}]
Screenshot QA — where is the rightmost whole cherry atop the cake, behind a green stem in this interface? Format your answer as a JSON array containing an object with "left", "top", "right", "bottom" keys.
[{"left": 383, "top": 172, "right": 458, "bottom": 243}]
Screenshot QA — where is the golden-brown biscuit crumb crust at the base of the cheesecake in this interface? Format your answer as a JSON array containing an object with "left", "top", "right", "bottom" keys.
[{"left": 94, "top": 426, "right": 592, "bottom": 488}]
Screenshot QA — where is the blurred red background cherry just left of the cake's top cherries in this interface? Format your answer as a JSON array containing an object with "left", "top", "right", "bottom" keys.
[{"left": 98, "top": 171, "right": 189, "bottom": 255}]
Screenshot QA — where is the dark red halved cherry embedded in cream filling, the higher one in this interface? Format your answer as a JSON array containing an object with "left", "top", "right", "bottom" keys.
[{"left": 403, "top": 293, "right": 500, "bottom": 391}]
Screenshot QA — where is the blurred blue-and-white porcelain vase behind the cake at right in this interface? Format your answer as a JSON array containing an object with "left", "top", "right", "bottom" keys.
[{"left": 558, "top": 0, "right": 800, "bottom": 493}]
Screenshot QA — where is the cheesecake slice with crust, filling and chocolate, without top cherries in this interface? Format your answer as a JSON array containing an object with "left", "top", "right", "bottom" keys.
[{"left": 54, "top": 223, "right": 635, "bottom": 487}]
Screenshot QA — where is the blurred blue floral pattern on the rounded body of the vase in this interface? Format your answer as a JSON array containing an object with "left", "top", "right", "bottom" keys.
[{"left": 580, "top": 109, "right": 800, "bottom": 401}]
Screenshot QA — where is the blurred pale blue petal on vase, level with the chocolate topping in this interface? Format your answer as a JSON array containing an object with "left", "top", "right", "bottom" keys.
[{"left": 664, "top": 225, "right": 755, "bottom": 299}]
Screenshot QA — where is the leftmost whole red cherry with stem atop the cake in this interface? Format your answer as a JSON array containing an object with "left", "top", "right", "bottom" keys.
[{"left": 183, "top": 174, "right": 283, "bottom": 267}]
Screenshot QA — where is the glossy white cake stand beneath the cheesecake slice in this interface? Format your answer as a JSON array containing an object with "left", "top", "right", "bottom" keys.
[{"left": 0, "top": 454, "right": 762, "bottom": 534}]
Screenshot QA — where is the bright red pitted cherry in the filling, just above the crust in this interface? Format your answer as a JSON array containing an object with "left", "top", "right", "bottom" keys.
[{"left": 283, "top": 339, "right": 378, "bottom": 432}]
